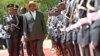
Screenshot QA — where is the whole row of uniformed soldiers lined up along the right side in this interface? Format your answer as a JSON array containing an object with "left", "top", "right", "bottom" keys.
[{"left": 47, "top": 0, "right": 100, "bottom": 56}]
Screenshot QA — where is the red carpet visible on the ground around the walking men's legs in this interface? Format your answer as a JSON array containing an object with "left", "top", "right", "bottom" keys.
[{"left": 0, "top": 48, "right": 53, "bottom": 56}]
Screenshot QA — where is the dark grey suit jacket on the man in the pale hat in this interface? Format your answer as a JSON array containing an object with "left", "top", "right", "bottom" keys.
[{"left": 24, "top": 11, "right": 46, "bottom": 40}]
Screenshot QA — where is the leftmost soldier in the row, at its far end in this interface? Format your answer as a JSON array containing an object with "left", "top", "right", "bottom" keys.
[{"left": 47, "top": 9, "right": 55, "bottom": 52}]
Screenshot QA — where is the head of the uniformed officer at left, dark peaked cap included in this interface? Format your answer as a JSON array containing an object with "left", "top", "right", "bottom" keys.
[{"left": 7, "top": 4, "right": 18, "bottom": 15}]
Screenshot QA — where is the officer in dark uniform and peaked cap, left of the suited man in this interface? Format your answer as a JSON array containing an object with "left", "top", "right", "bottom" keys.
[{"left": 3, "top": 4, "right": 23, "bottom": 56}]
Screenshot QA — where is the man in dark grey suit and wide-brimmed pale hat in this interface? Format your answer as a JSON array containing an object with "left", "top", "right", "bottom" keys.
[{"left": 24, "top": 1, "right": 46, "bottom": 56}]
